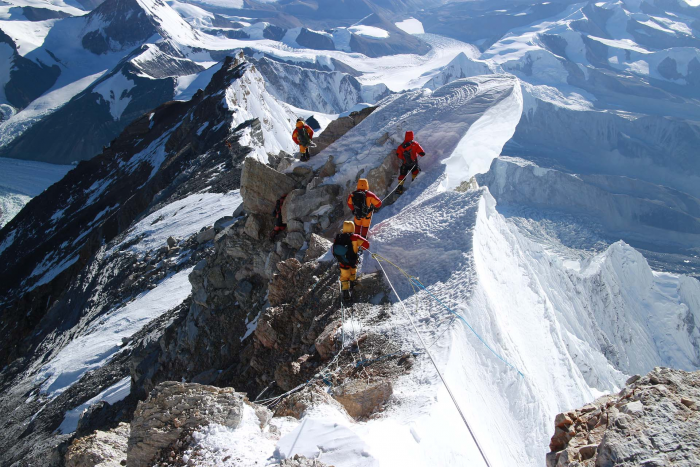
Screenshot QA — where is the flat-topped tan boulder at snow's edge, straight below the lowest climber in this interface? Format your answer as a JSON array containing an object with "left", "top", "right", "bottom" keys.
[{"left": 333, "top": 379, "right": 393, "bottom": 419}]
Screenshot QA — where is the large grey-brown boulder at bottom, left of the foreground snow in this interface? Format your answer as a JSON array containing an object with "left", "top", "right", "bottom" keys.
[{"left": 126, "top": 381, "right": 245, "bottom": 467}]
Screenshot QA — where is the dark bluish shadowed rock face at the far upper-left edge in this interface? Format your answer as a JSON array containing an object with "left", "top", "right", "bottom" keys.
[{"left": 0, "top": 30, "right": 61, "bottom": 109}]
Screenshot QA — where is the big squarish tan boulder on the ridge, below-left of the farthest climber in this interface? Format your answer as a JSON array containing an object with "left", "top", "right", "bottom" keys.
[{"left": 241, "top": 157, "right": 294, "bottom": 216}]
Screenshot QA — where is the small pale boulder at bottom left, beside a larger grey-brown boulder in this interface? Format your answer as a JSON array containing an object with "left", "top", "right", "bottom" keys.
[{"left": 64, "top": 423, "right": 130, "bottom": 467}]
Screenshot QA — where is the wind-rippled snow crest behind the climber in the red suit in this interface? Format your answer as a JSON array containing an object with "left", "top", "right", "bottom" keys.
[{"left": 311, "top": 75, "right": 522, "bottom": 192}]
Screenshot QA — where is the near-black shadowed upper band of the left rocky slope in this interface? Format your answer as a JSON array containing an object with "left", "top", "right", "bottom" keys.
[{"left": 0, "top": 55, "right": 248, "bottom": 370}]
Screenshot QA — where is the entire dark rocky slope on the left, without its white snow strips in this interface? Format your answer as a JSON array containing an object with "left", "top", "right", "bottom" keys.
[{"left": 0, "top": 55, "right": 255, "bottom": 465}]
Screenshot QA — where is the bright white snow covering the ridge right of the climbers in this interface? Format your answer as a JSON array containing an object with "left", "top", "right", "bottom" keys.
[{"left": 258, "top": 75, "right": 700, "bottom": 467}]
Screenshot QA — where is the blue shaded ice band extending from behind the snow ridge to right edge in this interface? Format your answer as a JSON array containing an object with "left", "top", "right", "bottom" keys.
[{"left": 478, "top": 157, "right": 700, "bottom": 250}]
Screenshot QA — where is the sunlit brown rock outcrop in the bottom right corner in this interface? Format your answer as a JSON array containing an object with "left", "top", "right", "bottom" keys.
[{"left": 547, "top": 368, "right": 700, "bottom": 467}]
